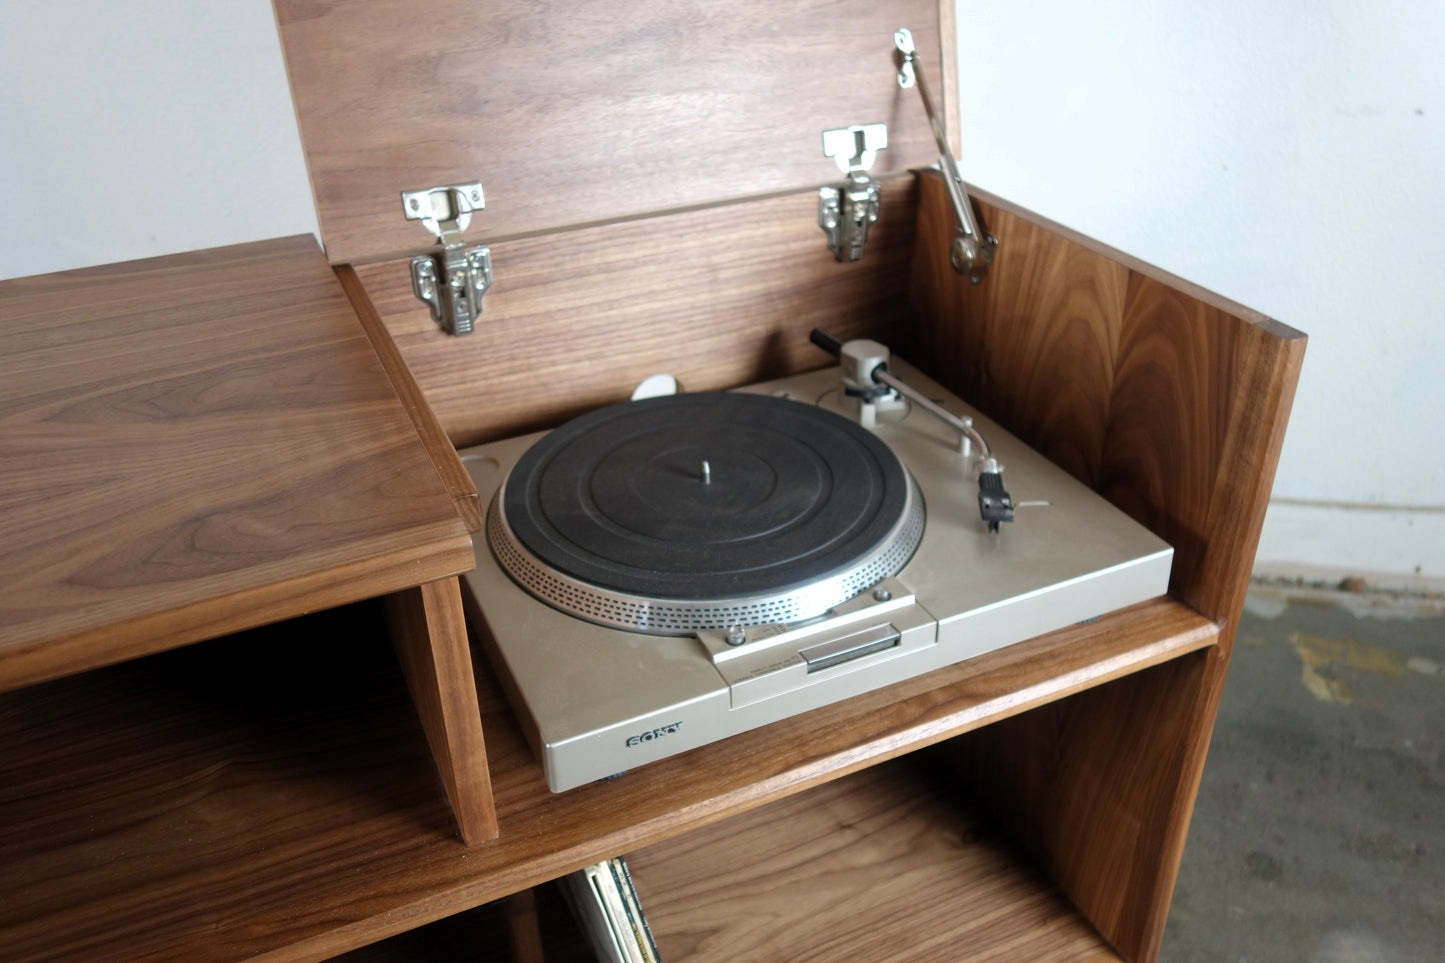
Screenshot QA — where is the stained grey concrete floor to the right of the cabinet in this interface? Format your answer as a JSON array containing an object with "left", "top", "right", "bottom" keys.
[{"left": 1159, "top": 584, "right": 1445, "bottom": 963}]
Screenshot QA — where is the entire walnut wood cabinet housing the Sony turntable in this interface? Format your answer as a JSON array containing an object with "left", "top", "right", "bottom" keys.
[{"left": 0, "top": 0, "right": 1305, "bottom": 960}]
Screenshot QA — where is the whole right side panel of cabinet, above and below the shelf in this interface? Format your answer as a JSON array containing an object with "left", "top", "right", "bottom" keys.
[{"left": 912, "top": 168, "right": 1305, "bottom": 960}]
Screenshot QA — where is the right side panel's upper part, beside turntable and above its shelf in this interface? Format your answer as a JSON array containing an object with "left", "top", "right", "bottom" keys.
[{"left": 909, "top": 174, "right": 1305, "bottom": 620}]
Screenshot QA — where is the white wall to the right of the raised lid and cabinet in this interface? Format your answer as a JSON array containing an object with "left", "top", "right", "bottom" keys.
[{"left": 958, "top": 0, "right": 1445, "bottom": 578}]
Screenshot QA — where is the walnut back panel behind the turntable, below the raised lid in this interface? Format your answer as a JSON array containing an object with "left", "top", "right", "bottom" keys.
[{"left": 349, "top": 178, "right": 918, "bottom": 447}]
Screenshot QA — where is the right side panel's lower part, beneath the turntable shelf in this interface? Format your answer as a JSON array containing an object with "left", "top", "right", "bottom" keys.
[{"left": 951, "top": 646, "right": 1225, "bottom": 960}]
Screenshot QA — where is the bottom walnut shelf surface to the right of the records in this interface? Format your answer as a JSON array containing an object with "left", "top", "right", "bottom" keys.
[{"left": 627, "top": 753, "right": 1120, "bottom": 963}]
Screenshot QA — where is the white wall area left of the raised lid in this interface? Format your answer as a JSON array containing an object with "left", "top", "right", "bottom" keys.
[{"left": 0, "top": 0, "right": 316, "bottom": 278}]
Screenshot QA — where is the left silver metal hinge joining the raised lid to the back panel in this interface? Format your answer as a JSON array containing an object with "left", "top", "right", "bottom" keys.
[{"left": 402, "top": 182, "right": 491, "bottom": 334}]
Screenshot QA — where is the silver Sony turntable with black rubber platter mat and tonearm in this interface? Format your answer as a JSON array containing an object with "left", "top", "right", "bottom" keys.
[{"left": 461, "top": 333, "right": 1173, "bottom": 792}]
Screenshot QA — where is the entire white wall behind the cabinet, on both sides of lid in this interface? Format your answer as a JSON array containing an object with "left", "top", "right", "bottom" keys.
[{"left": 0, "top": 0, "right": 1445, "bottom": 577}]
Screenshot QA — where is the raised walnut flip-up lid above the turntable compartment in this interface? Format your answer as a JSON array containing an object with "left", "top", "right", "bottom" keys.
[{"left": 276, "top": 0, "right": 952, "bottom": 263}]
